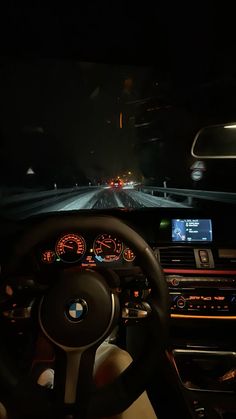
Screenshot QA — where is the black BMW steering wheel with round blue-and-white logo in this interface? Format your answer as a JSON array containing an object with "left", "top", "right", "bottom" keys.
[{"left": 0, "top": 214, "right": 169, "bottom": 419}]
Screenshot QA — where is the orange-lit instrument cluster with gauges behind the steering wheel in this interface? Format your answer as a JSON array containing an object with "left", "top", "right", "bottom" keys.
[{"left": 39, "top": 233, "right": 135, "bottom": 267}]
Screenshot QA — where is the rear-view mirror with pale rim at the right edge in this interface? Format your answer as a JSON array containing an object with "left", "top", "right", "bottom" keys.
[{"left": 191, "top": 123, "right": 236, "bottom": 159}]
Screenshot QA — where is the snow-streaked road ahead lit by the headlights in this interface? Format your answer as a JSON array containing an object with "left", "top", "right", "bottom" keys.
[{"left": 1, "top": 187, "right": 187, "bottom": 218}]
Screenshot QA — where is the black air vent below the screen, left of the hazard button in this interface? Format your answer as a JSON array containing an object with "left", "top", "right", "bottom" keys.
[{"left": 157, "top": 246, "right": 196, "bottom": 269}]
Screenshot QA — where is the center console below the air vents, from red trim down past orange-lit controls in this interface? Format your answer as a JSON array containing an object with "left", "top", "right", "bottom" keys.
[{"left": 166, "top": 270, "right": 236, "bottom": 419}]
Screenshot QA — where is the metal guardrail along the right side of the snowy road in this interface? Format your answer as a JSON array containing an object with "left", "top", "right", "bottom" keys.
[{"left": 136, "top": 185, "right": 236, "bottom": 205}]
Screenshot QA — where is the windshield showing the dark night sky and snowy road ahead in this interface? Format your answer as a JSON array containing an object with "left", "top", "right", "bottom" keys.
[{"left": 0, "top": 58, "right": 236, "bottom": 218}]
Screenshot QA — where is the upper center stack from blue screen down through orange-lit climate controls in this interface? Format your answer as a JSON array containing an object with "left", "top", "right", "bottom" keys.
[{"left": 155, "top": 218, "right": 236, "bottom": 320}]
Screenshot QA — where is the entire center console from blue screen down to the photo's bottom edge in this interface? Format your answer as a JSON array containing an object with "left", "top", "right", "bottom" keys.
[{"left": 155, "top": 219, "right": 236, "bottom": 419}]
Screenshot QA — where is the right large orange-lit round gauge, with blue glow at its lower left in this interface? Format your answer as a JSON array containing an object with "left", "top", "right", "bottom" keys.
[{"left": 93, "top": 234, "right": 123, "bottom": 262}]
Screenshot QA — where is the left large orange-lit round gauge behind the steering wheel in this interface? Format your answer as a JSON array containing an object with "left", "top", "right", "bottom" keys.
[{"left": 56, "top": 234, "right": 86, "bottom": 263}]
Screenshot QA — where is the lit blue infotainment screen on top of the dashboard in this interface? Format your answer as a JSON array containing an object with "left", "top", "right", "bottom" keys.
[{"left": 172, "top": 219, "right": 212, "bottom": 243}]
